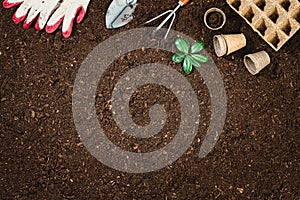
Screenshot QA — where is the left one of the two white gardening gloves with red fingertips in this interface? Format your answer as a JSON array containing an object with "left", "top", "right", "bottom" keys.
[{"left": 3, "top": 0, "right": 59, "bottom": 30}]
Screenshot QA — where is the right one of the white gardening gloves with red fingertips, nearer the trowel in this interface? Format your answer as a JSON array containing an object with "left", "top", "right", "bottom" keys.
[{"left": 46, "top": 0, "right": 90, "bottom": 38}]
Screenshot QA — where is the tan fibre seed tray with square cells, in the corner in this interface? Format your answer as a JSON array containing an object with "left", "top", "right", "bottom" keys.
[{"left": 227, "top": 0, "right": 300, "bottom": 51}]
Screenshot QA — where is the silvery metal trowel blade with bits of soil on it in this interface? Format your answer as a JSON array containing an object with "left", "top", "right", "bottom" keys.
[{"left": 106, "top": 0, "right": 137, "bottom": 29}]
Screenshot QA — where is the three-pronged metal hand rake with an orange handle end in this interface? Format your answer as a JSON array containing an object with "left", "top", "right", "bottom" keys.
[{"left": 144, "top": 0, "right": 190, "bottom": 39}]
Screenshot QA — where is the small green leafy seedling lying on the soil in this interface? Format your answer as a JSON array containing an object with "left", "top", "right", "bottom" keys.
[{"left": 172, "top": 38, "right": 208, "bottom": 74}]
